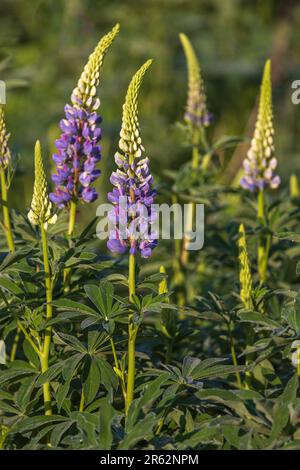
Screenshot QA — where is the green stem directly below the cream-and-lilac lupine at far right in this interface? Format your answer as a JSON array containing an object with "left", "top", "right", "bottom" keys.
[{"left": 257, "top": 189, "right": 271, "bottom": 283}]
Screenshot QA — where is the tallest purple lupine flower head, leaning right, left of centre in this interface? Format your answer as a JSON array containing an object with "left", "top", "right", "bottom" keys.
[{"left": 50, "top": 25, "right": 119, "bottom": 208}]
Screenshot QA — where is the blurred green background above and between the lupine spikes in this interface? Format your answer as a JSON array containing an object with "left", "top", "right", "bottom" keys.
[{"left": 0, "top": 0, "right": 300, "bottom": 222}]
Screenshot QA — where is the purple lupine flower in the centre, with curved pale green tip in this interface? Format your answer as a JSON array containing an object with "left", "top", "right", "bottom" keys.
[{"left": 107, "top": 60, "right": 157, "bottom": 258}]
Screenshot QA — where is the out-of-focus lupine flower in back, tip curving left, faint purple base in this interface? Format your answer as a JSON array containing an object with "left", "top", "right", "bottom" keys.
[{"left": 179, "top": 33, "right": 212, "bottom": 129}]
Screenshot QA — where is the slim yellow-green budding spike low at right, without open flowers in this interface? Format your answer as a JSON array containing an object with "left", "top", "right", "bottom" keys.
[{"left": 238, "top": 224, "right": 252, "bottom": 310}]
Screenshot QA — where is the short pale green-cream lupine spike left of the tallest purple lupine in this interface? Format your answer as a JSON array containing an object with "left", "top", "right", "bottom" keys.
[{"left": 28, "top": 140, "right": 57, "bottom": 230}]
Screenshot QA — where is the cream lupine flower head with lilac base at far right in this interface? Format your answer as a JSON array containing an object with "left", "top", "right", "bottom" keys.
[{"left": 241, "top": 60, "right": 280, "bottom": 191}]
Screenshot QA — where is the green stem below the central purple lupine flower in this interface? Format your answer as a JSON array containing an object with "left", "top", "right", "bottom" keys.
[{"left": 125, "top": 254, "right": 137, "bottom": 415}]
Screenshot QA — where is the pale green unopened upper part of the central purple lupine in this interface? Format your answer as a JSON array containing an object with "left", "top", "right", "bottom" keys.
[{"left": 118, "top": 59, "right": 152, "bottom": 160}]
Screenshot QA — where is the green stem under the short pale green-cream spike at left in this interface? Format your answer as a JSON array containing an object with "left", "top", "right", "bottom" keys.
[{"left": 40, "top": 224, "right": 52, "bottom": 415}]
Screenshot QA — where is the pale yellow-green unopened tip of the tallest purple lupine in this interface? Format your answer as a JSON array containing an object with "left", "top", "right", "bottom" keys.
[{"left": 71, "top": 24, "right": 120, "bottom": 109}]
